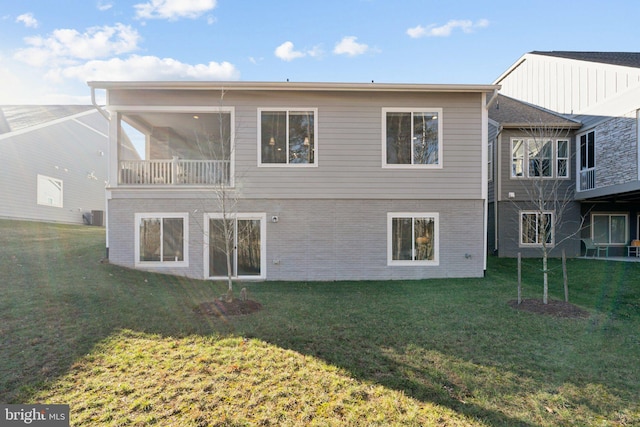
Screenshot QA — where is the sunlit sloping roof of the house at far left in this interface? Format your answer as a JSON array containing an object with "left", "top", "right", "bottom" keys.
[{"left": 0, "top": 105, "right": 94, "bottom": 134}]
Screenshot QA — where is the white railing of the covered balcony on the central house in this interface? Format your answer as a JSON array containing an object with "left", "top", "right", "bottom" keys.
[{"left": 118, "top": 157, "right": 231, "bottom": 185}]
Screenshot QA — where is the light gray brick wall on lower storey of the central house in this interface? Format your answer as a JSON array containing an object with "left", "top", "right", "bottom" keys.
[{"left": 109, "top": 195, "right": 484, "bottom": 281}]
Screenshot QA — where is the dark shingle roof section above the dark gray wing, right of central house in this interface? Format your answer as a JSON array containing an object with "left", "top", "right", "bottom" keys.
[{"left": 489, "top": 95, "right": 581, "bottom": 128}]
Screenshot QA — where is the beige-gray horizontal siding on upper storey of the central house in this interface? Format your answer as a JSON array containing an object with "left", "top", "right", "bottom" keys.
[{"left": 109, "top": 90, "right": 483, "bottom": 200}]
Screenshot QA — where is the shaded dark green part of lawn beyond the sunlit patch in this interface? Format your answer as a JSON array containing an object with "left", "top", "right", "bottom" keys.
[{"left": 0, "top": 221, "right": 640, "bottom": 426}]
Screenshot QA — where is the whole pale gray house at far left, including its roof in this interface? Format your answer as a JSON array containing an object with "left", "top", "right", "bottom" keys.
[{"left": 0, "top": 105, "right": 109, "bottom": 224}]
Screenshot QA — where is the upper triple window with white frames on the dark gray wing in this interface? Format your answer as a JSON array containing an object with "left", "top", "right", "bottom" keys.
[{"left": 511, "top": 139, "right": 569, "bottom": 178}]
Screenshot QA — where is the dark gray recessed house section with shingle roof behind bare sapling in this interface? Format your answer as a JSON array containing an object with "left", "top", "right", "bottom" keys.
[{"left": 487, "top": 95, "right": 582, "bottom": 257}]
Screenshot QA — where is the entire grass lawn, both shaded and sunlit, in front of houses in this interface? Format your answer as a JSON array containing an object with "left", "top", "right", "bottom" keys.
[{"left": 0, "top": 220, "right": 640, "bottom": 426}]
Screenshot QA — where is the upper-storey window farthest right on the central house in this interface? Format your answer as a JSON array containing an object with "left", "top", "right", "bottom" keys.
[{"left": 382, "top": 108, "right": 442, "bottom": 167}]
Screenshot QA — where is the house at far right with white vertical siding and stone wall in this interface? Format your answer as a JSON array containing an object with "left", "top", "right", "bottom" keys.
[{"left": 494, "top": 51, "right": 640, "bottom": 256}]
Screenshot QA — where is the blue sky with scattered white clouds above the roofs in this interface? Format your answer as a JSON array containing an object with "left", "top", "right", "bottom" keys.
[{"left": 0, "top": 0, "right": 640, "bottom": 105}]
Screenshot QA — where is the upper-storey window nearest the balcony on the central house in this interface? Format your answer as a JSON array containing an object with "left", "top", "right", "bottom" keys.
[{"left": 258, "top": 109, "right": 317, "bottom": 166}]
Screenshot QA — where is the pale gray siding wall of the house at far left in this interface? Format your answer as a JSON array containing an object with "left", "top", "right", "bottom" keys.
[{"left": 0, "top": 111, "right": 108, "bottom": 224}]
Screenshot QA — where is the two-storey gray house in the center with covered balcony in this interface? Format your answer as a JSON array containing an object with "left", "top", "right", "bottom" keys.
[{"left": 89, "top": 82, "right": 498, "bottom": 281}]
